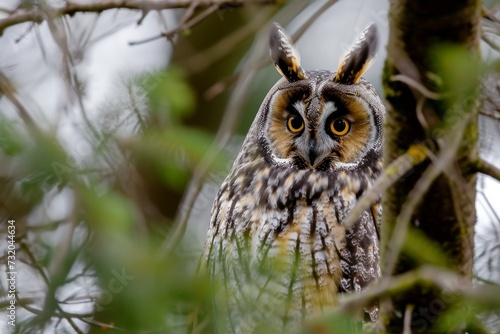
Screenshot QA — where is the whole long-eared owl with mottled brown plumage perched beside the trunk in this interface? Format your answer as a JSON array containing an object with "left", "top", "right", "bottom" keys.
[{"left": 200, "top": 23, "right": 385, "bottom": 333}]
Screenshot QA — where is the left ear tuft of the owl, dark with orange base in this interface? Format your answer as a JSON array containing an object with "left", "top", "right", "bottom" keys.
[{"left": 269, "top": 22, "right": 307, "bottom": 82}]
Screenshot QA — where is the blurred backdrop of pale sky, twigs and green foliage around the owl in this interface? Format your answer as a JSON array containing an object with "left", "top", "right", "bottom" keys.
[{"left": 0, "top": 0, "right": 500, "bottom": 333}]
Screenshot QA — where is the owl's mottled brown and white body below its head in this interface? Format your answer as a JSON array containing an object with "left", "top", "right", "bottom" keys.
[{"left": 204, "top": 153, "right": 381, "bottom": 332}]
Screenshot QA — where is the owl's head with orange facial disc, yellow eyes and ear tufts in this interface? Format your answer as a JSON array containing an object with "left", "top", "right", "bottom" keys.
[{"left": 249, "top": 23, "right": 385, "bottom": 171}]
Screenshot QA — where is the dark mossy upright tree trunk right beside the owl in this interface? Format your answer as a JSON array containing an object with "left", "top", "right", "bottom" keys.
[{"left": 381, "top": 0, "right": 481, "bottom": 333}]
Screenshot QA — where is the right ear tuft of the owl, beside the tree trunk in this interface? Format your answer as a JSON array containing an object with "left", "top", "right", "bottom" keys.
[{"left": 333, "top": 23, "right": 378, "bottom": 85}]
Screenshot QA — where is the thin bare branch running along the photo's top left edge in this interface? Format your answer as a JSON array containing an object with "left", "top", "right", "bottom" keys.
[{"left": 0, "top": 0, "right": 278, "bottom": 36}]
